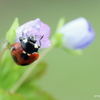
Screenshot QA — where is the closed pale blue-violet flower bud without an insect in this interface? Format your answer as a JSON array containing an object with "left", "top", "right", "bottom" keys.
[{"left": 59, "top": 18, "right": 95, "bottom": 49}]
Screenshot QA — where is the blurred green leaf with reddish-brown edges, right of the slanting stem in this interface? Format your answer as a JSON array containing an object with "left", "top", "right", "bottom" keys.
[{"left": 17, "top": 62, "right": 55, "bottom": 100}]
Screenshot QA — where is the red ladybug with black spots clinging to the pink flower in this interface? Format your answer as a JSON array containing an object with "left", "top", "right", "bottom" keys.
[{"left": 10, "top": 34, "right": 43, "bottom": 66}]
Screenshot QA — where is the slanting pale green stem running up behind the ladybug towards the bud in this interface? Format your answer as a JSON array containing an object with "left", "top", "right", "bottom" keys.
[{"left": 10, "top": 46, "right": 54, "bottom": 93}]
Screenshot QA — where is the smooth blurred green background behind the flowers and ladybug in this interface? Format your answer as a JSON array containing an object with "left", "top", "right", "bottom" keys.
[{"left": 0, "top": 0, "right": 100, "bottom": 100}]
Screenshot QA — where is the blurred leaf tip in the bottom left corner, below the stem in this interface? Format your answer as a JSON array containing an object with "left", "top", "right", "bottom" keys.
[{"left": 0, "top": 89, "right": 25, "bottom": 100}]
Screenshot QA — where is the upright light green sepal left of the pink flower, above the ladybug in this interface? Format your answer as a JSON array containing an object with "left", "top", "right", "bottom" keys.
[{"left": 6, "top": 18, "right": 19, "bottom": 44}]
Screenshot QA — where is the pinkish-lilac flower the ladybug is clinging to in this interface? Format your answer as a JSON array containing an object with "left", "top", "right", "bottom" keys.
[{"left": 15, "top": 18, "right": 51, "bottom": 48}]
